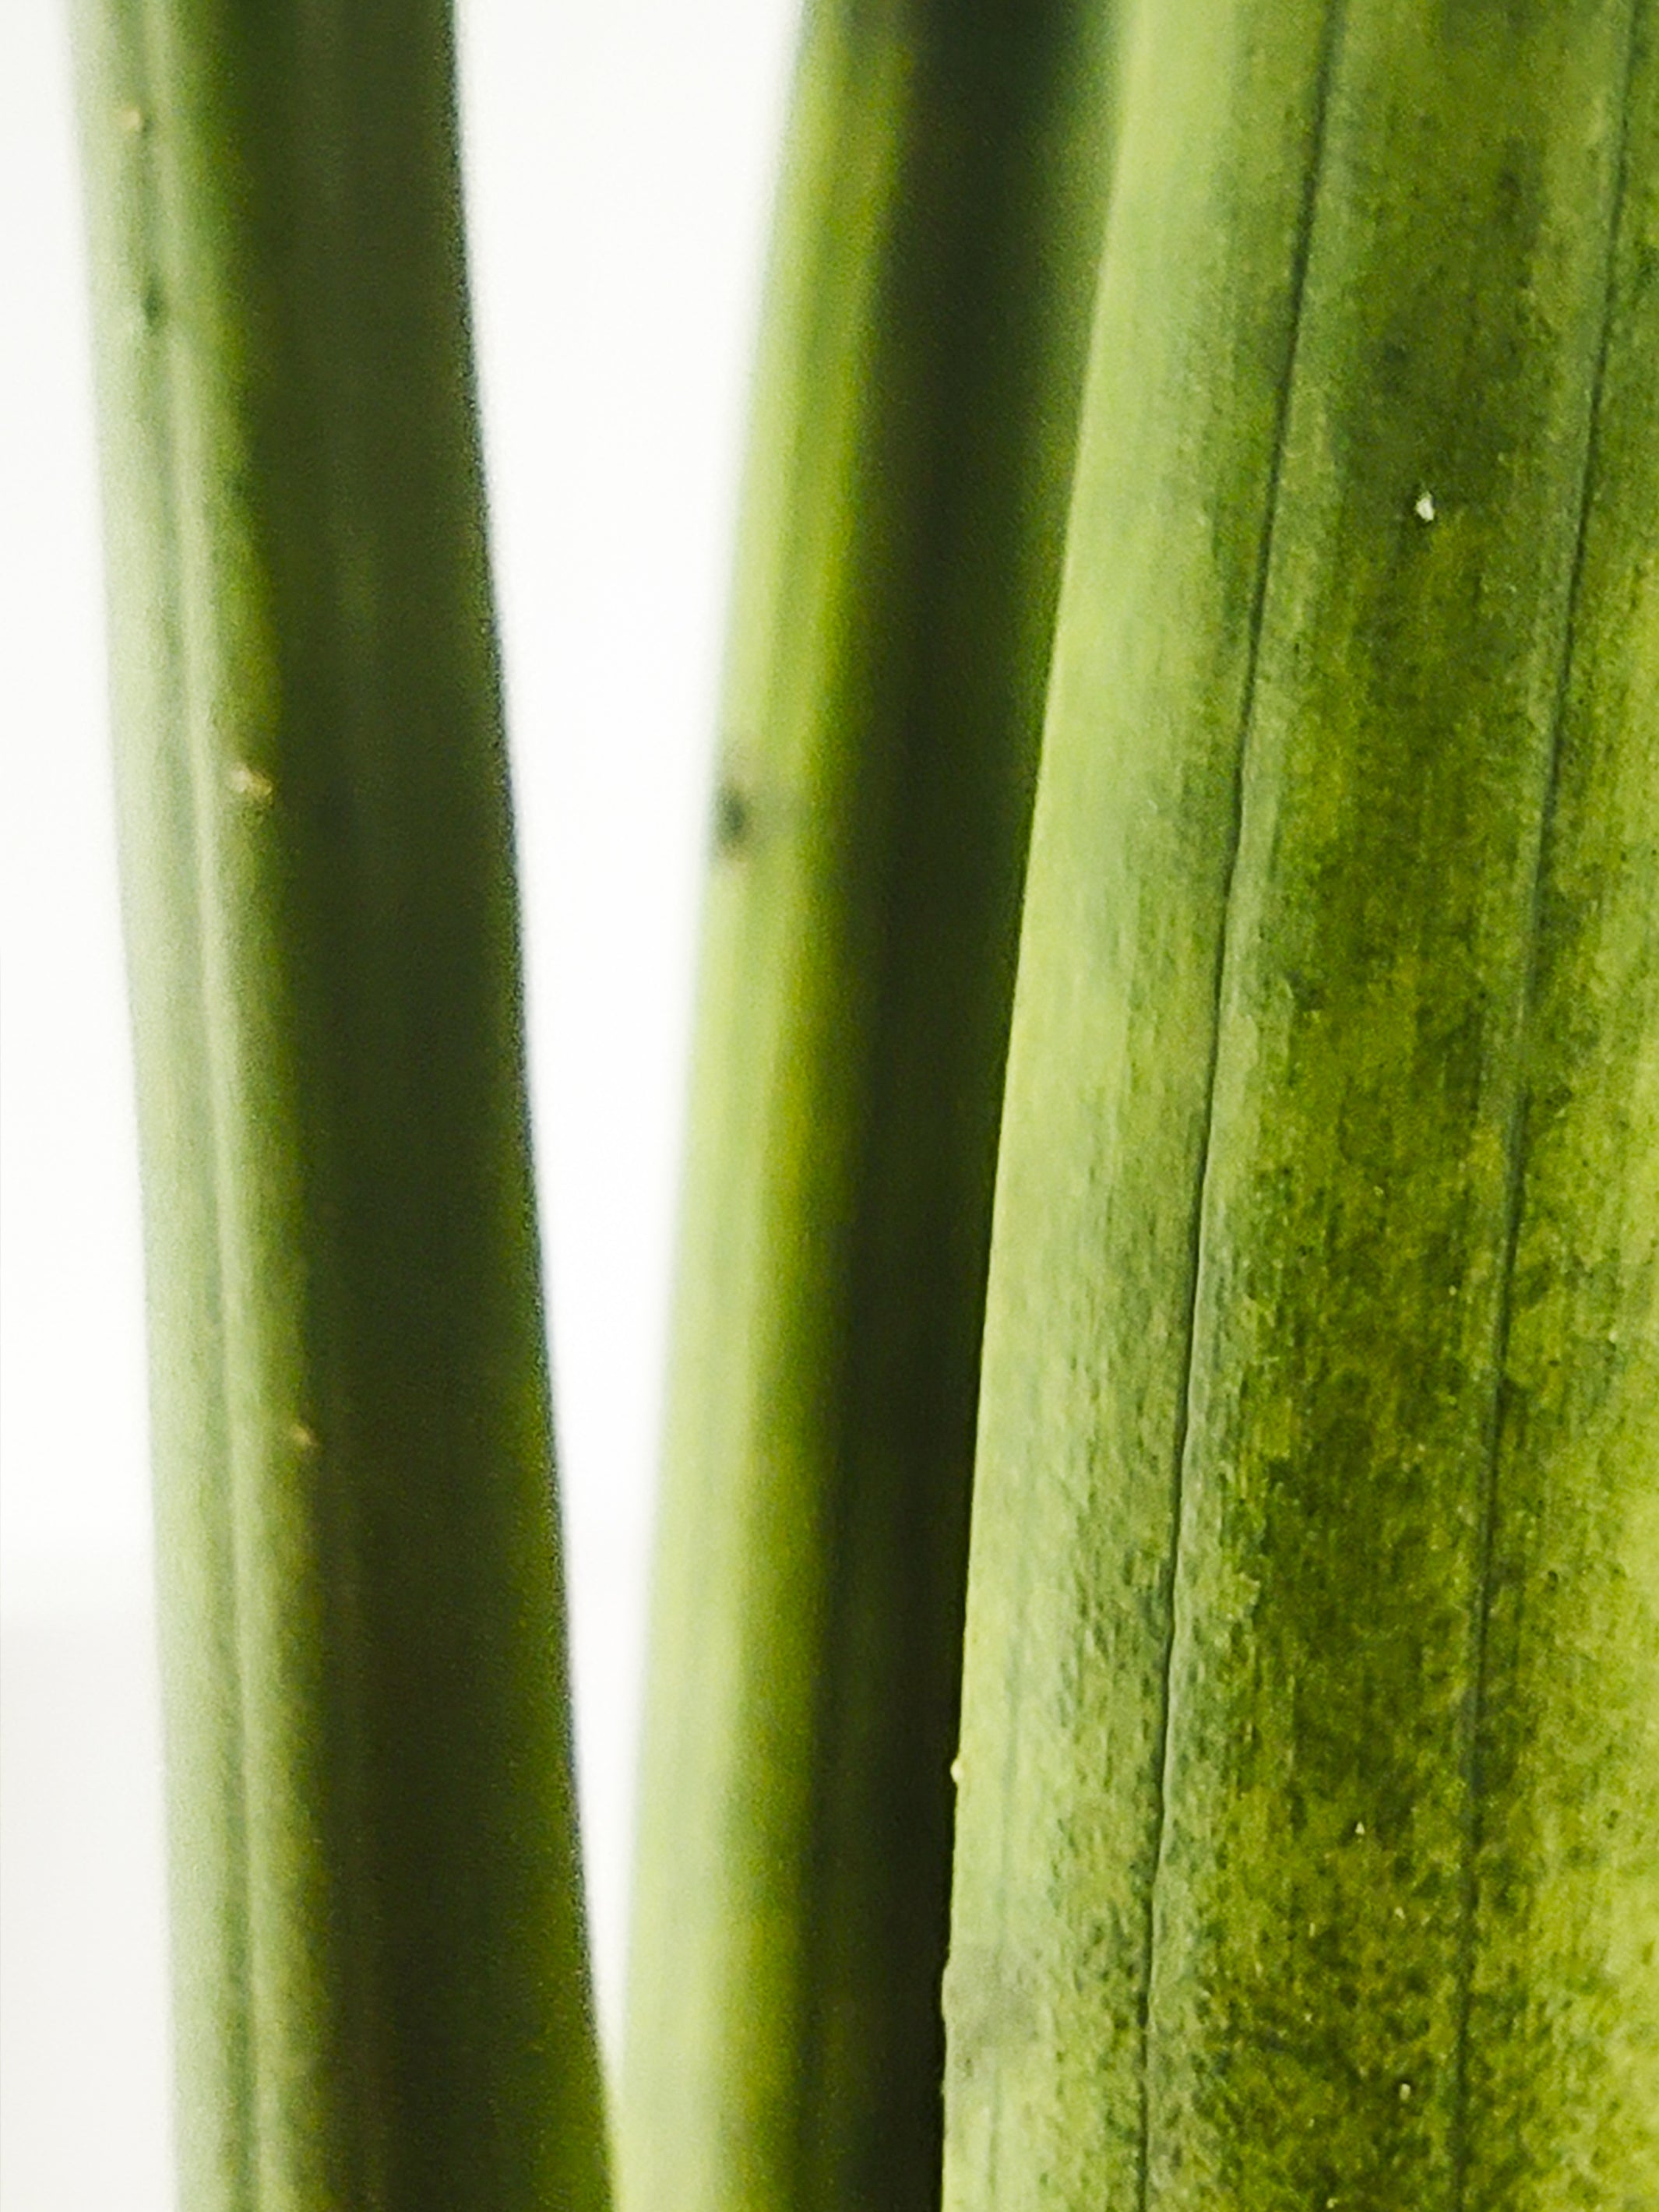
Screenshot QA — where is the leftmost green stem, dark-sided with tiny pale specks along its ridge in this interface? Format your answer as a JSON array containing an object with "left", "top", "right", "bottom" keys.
[{"left": 77, "top": 0, "right": 606, "bottom": 2212}]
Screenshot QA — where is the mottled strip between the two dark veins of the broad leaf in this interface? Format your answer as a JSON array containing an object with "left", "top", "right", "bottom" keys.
[{"left": 1153, "top": 7, "right": 1654, "bottom": 2205}]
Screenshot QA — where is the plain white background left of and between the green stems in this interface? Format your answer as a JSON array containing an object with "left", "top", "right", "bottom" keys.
[{"left": 0, "top": 0, "right": 794, "bottom": 2212}]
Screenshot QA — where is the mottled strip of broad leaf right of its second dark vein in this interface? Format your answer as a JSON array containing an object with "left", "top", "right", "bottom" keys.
[{"left": 1464, "top": 5, "right": 1659, "bottom": 2212}]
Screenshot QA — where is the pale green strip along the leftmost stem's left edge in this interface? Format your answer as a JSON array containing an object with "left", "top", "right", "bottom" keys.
[{"left": 76, "top": 9, "right": 255, "bottom": 2212}]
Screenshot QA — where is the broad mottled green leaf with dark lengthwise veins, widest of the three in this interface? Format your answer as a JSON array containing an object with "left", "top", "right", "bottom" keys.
[{"left": 947, "top": 0, "right": 1659, "bottom": 2212}]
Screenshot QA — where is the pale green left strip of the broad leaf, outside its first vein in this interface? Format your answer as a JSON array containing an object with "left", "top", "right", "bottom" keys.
[{"left": 945, "top": 0, "right": 1330, "bottom": 2212}]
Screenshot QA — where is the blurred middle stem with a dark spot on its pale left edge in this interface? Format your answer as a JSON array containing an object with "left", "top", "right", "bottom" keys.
[{"left": 622, "top": 0, "right": 1115, "bottom": 2212}]
